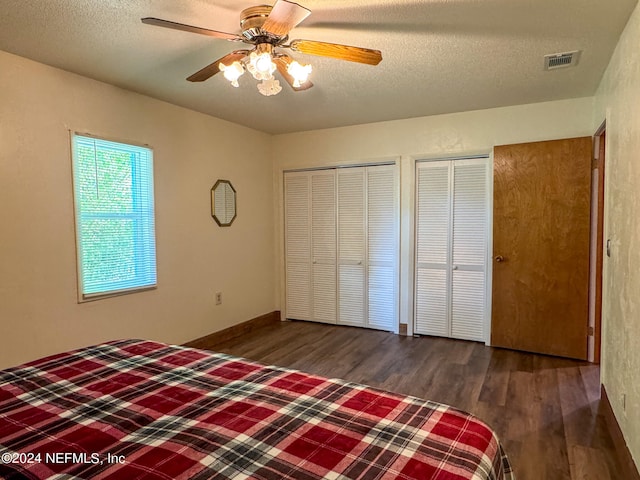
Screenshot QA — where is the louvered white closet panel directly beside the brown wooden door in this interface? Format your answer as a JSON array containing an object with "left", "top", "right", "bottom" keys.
[{"left": 451, "top": 158, "right": 488, "bottom": 341}]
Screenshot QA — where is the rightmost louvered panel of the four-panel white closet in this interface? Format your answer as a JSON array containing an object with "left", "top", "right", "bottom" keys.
[{"left": 367, "top": 165, "right": 398, "bottom": 331}]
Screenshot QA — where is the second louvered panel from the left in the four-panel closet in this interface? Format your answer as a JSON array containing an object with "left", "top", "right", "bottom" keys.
[{"left": 310, "top": 170, "right": 337, "bottom": 323}]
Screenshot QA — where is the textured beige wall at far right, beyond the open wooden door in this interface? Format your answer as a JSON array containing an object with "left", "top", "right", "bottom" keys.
[{"left": 594, "top": 0, "right": 640, "bottom": 466}]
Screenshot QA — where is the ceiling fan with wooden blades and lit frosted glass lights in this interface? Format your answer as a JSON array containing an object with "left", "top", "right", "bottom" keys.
[{"left": 142, "top": 0, "right": 382, "bottom": 96}]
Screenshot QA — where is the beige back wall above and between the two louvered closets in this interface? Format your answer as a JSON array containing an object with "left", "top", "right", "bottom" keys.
[{"left": 273, "top": 97, "right": 593, "bottom": 334}]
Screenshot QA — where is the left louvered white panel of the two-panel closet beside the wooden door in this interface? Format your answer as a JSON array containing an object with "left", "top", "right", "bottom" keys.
[{"left": 415, "top": 162, "right": 451, "bottom": 337}]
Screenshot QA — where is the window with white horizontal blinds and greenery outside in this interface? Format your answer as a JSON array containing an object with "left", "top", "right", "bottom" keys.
[{"left": 72, "top": 134, "right": 156, "bottom": 300}]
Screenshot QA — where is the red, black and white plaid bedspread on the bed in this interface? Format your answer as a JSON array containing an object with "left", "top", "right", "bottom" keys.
[{"left": 0, "top": 340, "right": 513, "bottom": 480}]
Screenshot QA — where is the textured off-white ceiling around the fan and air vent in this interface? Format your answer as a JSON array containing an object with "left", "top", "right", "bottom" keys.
[{"left": 0, "top": 0, "right": 637, "bottom": 133}]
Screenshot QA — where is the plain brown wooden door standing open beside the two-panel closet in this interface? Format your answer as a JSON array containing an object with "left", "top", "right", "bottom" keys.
[{"left": 491, "top": 137, "right": 591, "bottom": 359}]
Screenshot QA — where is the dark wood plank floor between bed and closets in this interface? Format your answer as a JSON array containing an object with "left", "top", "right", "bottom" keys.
[{"left": 202, "top": 322, "right": 623, "bottom": 480}]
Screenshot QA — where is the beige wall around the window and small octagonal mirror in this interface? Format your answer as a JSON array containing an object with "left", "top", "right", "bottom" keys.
[{"left": 0, "top": 52, "right": 275, "bottom": 368}]
